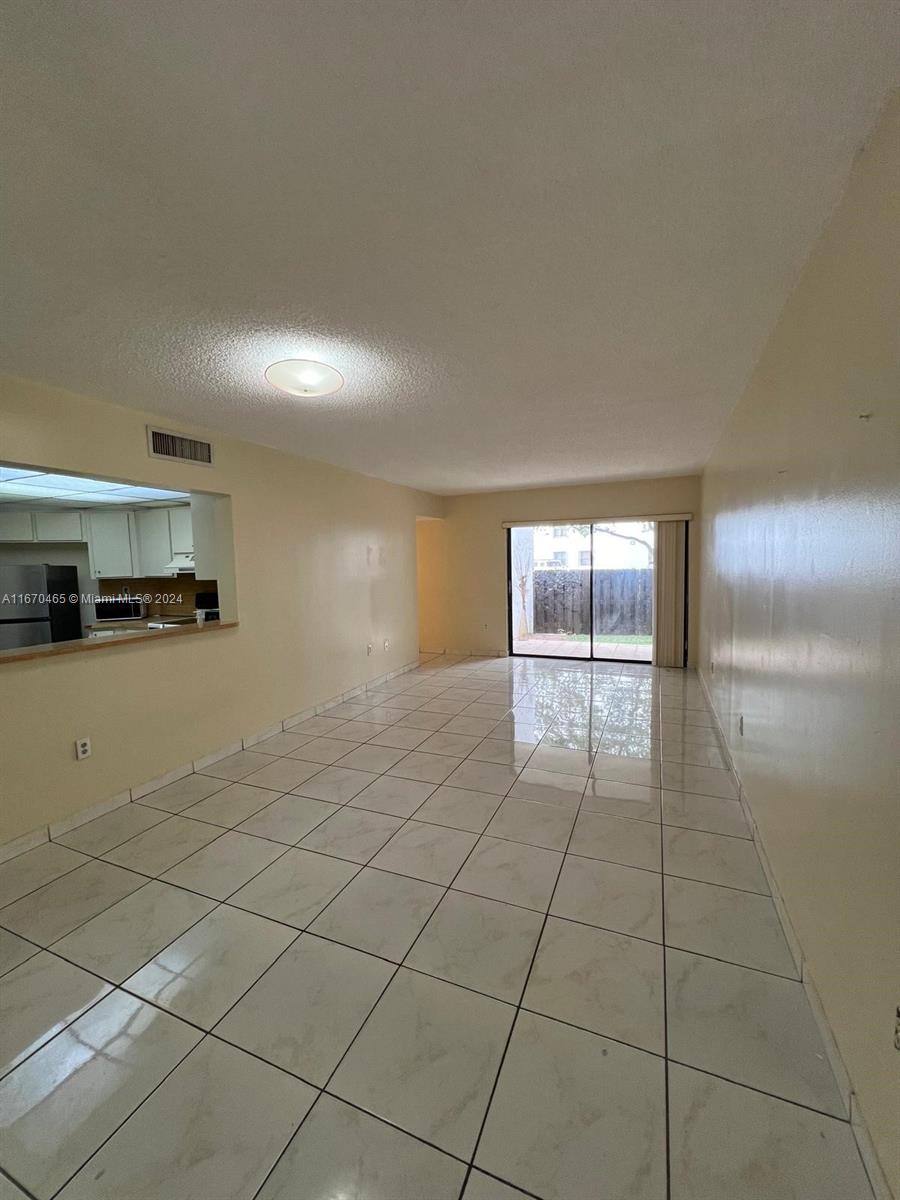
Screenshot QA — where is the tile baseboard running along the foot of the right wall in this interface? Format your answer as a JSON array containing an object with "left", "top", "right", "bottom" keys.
[{"left": 697, "top": 670, "right": 894, "bottom": 1200}]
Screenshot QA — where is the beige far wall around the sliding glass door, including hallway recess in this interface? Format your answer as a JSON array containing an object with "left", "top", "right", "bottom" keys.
[{"left": 419, "top": 475, "right": 700, "bottom": 661}]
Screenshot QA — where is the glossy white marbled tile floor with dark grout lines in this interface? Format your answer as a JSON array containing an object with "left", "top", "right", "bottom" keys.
[{"left": 0, "top": 659, "right": 871, "bottom": 1200}]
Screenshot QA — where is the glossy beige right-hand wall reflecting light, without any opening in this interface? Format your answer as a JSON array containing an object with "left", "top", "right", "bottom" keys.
[{"left": 701, "top": 93, "right": 900, "bottom": 1195}]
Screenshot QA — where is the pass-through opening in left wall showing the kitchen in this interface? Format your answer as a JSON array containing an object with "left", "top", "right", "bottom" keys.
[{"left": 0, "top": 462, "right": 236, "bottom": 660}]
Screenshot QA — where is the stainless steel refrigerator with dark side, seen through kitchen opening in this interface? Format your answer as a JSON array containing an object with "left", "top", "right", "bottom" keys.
[{"left": 0, "top": 563, "right": 84, "bottom": 650}]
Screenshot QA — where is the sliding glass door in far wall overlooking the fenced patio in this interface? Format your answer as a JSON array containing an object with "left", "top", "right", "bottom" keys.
[{"left": 508, "top": 521, "right": 655, "bottom": 662}]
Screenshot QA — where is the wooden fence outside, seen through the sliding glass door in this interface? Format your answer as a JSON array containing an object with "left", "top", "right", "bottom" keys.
[{"left": 534, "top": 568, "right": 653, "bottom": 636}]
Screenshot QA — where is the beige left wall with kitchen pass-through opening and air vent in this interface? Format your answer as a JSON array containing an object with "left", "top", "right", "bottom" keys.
[{"left": 0, "top": 379, "right": 440, "bottom": 842}]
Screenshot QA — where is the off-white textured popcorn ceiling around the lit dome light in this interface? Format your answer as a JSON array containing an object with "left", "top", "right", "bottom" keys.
[{"left": 0, "top": 0, "right": 898, "bottom": 492}]
